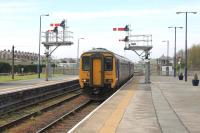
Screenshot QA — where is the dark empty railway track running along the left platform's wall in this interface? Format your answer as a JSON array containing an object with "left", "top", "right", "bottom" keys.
[{"left": 0, "top": 80, "right": 79, "bottom": 115}]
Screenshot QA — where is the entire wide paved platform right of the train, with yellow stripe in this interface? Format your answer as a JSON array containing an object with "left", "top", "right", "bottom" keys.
[{"left": 69, "top": 76, "right": 200, "bottom": 133}]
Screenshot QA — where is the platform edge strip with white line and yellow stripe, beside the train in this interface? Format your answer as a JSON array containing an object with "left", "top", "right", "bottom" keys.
[{"left": 69, "top": 77, "right": 138, "bottom": 133}]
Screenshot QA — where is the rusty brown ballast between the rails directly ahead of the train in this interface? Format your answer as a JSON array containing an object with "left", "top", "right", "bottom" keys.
[{"left": 6, "top": 95, "right": 92, "bottom": 133}]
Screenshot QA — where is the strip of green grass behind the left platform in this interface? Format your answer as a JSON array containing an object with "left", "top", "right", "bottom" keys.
[{"left": 0, "top": 74, "right": 63, "bottom": 82}]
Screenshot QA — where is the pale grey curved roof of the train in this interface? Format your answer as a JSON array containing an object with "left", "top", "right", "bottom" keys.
[{"left": 82, "top": 48, "right": 132, "bottom": 62}]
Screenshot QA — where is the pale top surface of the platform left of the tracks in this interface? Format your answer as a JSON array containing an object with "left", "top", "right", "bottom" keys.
[{"left": 0, "top": 75, "right": 78, "bottom": 95}]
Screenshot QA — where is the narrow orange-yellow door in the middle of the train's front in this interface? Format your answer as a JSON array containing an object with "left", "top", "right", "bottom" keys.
[{"left": 92, "top": 58, "right": 102, "bottom": 86}]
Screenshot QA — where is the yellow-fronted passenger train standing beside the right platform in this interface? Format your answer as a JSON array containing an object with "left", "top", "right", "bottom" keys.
[{"left": 79, "top": 48, "right": 134, "bottom": 100}]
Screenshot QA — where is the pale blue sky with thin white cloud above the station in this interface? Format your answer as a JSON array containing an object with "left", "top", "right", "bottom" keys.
[{"left": 0, "top": 0, "right": 200, "bottom": 62}]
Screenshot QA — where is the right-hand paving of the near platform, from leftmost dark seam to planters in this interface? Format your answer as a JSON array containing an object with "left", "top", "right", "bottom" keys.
[{"left": 151, "top": 76, "right": 200, "bottom": 133}]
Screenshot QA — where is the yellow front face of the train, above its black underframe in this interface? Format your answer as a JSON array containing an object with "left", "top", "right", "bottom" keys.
[{"left": 79, "top": 53, "right": 117, "bottom": 88}]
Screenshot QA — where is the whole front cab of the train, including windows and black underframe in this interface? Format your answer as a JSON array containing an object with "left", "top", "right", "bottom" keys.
[{"left": 80, "top": 53, "right": 117, "bottom": 99}]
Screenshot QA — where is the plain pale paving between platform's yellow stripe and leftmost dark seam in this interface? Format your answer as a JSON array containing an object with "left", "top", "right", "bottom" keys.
[{"left": 117, "top": 80, "right": 161, "bottom": 133}]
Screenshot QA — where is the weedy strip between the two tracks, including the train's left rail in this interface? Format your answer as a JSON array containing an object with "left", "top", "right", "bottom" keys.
[{"left": 0, "top": 83, "right": 81, "bottom": 132}]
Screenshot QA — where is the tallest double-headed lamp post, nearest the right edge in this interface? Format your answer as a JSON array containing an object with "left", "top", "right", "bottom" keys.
[{"left": 176, "top": 12, "right": 197, "bottom": 82}]
